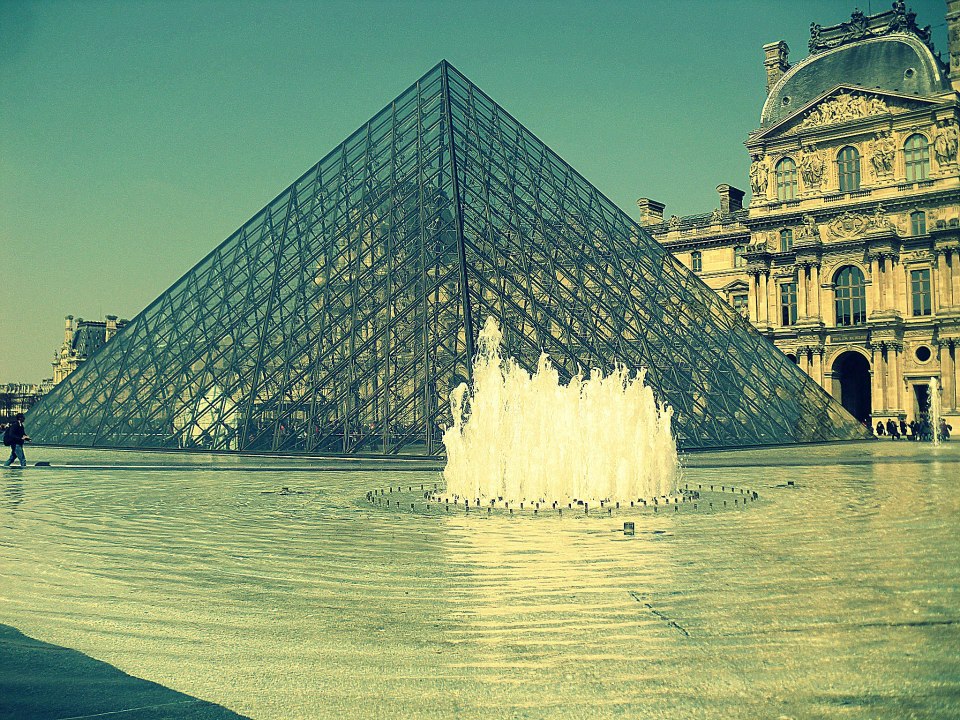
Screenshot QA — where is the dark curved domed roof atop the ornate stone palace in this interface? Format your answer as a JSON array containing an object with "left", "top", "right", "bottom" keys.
[{"left": 760, "top": 33, "right": 951, "bottom": 127}]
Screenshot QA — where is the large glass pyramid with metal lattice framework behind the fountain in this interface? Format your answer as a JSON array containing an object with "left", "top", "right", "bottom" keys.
[{"left": 29, "top": 61, "right": 867, "bottom": 455}]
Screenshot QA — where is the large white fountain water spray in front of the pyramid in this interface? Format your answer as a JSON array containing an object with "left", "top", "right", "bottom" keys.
[{"left": 443, "top": 318, "right": 679, "bottom": 505}]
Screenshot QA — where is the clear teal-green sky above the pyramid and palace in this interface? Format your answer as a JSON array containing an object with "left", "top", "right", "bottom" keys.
[{"left": 0, "top": 0, "right": 946, "bottom": 383}]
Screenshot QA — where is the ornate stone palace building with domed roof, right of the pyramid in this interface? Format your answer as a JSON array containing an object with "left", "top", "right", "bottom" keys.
[{"left": 637, "top": 0, "right": 960, "bottom": 428}]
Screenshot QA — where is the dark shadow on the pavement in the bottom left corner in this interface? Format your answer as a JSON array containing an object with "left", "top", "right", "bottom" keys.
[{"left": 0, "top": 624, "right": 249, "bottom": 720}]
